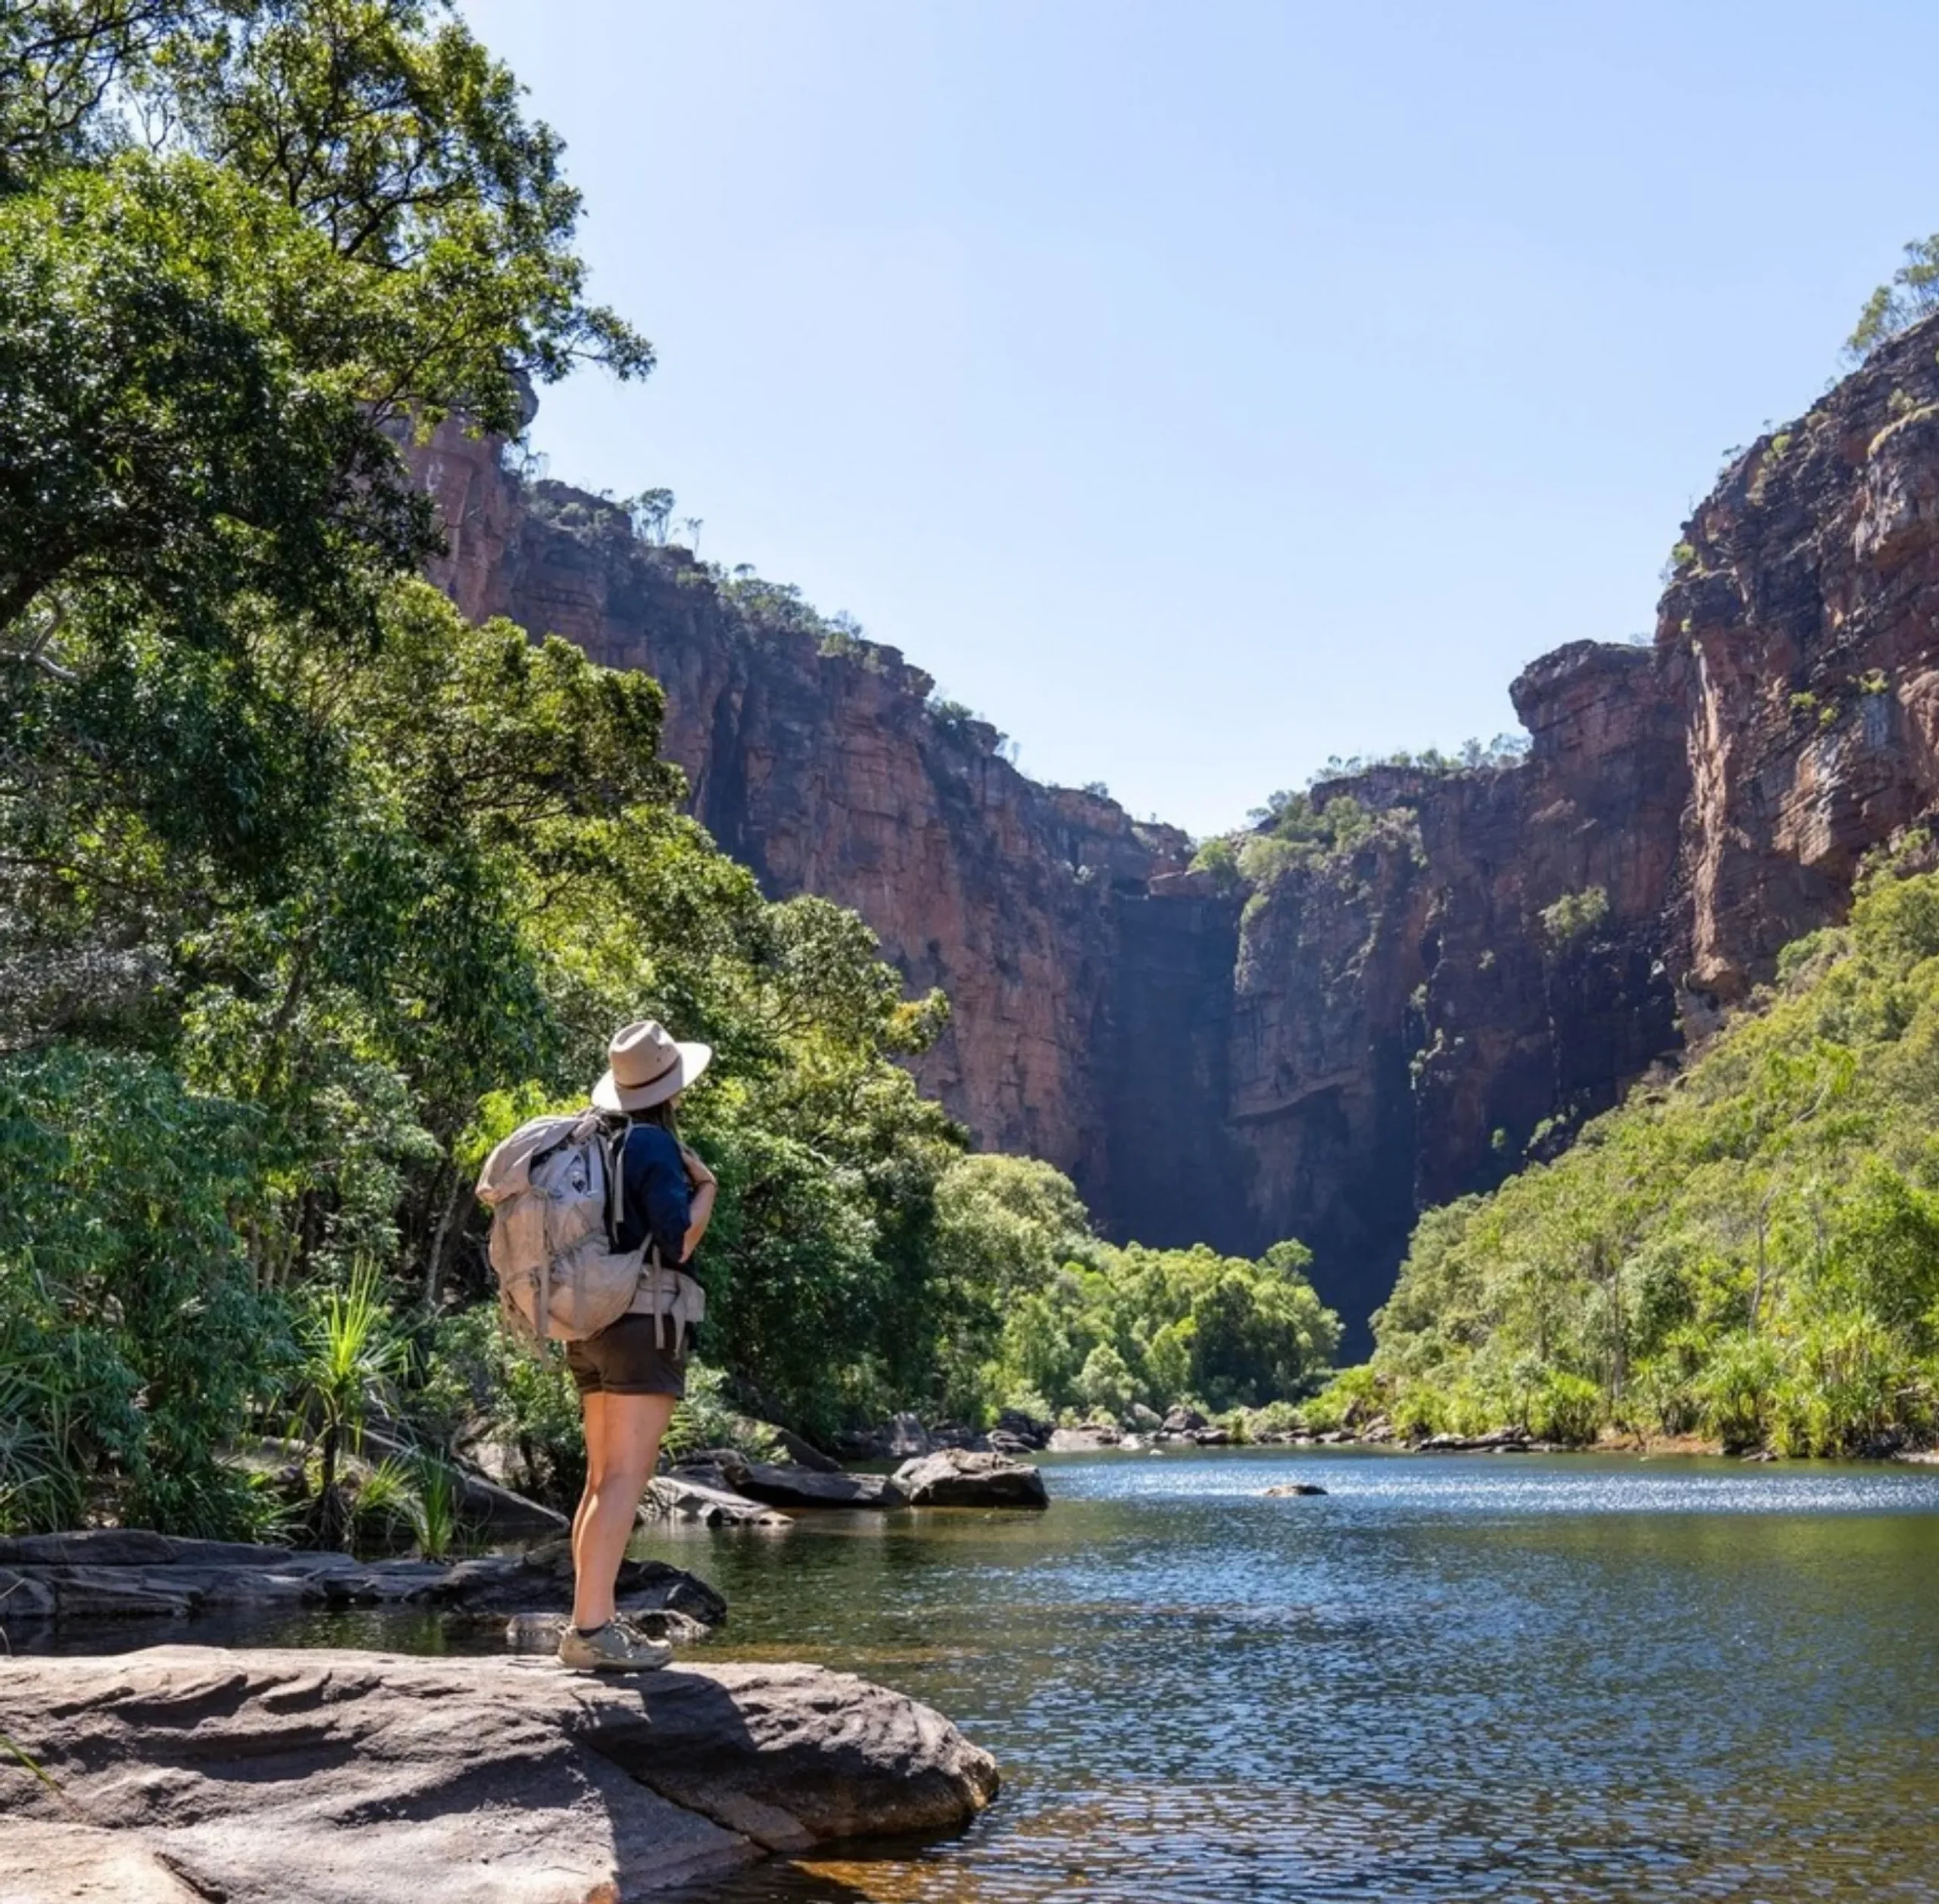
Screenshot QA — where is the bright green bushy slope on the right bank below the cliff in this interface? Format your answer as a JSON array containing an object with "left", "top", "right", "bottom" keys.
[{"left": 1315, "top": 841, "right": 1939, "bottom": 1454}]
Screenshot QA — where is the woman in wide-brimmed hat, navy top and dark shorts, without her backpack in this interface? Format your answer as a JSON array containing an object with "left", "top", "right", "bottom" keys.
[{"left": 558, "top": 1020, "right": 717, "bottom": 1671}]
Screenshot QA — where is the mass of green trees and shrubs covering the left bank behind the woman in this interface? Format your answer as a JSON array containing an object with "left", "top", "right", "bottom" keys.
[{"left": 0, "top": 0, "right": 1330, "bottom": 1531}]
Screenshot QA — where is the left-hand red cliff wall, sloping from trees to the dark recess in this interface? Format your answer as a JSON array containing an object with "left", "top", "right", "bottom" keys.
[{"left": 419, "top": 425, "right": 1186, "bottom": 1208}]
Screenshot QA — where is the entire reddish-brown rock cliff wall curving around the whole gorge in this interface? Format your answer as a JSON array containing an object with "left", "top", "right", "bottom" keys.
[{"left": 419, "top": 324, "right": 1939, "bottom": 1322}]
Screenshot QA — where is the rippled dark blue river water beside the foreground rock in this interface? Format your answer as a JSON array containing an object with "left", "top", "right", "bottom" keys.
[{"left": 648, "top": 1450, "right": 1939, "bottom": 1904}]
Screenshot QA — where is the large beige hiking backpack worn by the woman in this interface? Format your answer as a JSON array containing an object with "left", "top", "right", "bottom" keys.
[{"left": 477, "top": 1111, "right": 706, "bottom": 1347}]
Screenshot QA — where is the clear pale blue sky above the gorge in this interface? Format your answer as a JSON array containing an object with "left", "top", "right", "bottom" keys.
[{"left": 464, "top": 0, "right": 1939, "bottom": 834}]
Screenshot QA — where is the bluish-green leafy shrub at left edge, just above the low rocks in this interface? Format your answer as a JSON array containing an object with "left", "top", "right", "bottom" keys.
[{"left": 0, "top": 1045, "right": 291, "bottom": 1536}]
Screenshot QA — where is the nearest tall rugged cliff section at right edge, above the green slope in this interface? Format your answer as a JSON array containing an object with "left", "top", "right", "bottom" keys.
[{"left": 1658, "top": 337, "right": 1939, "bottom": 1000}]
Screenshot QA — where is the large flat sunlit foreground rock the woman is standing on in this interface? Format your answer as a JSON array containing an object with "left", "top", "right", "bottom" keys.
[{"left": 0, "top": 1646, "right": 997, "bottom": 1904}]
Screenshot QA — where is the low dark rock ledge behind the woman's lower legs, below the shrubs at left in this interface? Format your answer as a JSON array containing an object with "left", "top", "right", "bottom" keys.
[{"left": 0, "top": 1528, "right": 727, "bottom": 1621}]
